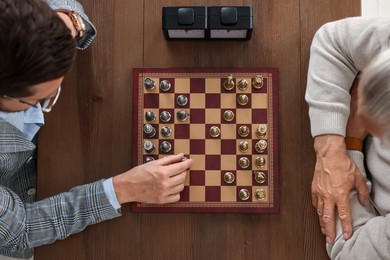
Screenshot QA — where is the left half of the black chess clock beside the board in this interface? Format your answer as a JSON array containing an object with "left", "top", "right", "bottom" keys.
[{"left": 162, "top": 6, "right": 207, "bottom": 39}]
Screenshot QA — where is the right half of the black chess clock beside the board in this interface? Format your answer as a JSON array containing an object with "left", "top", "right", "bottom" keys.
[{"left": 208, "top": 6, "right": 253, "bottom": 40}]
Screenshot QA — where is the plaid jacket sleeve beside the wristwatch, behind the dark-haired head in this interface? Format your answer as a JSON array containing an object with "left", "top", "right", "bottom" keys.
[{"left": 46, "top": 0, "right": 96, "bottom": 50}]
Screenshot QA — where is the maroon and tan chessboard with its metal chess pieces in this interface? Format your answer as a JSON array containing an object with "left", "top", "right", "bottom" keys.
[{"left": 132, "top": 68, "right": 279, "bottom": 213}]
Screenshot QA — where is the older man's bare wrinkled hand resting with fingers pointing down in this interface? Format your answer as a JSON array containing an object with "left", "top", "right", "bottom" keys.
[{"left": 312, "top": 135, "right": 369, "bottom": 243}]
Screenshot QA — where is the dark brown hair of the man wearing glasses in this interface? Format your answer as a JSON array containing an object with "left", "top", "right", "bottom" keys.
[{"left": 0, "top": 0, "right": 76, "bottom": 97}]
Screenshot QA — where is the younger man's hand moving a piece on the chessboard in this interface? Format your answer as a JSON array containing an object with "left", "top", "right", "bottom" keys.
[{"left": 113, "top": 154, "right": 193, "bottom": 204}]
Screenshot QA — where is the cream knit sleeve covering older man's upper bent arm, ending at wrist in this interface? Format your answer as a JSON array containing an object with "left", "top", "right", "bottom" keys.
[{"left": 305, "top": 17, "right": 390, "bottom": 136}]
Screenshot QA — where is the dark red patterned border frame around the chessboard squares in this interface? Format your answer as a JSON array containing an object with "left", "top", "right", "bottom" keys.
[{"left": 132, "top": 67, "right": 280, "bottom": 213}]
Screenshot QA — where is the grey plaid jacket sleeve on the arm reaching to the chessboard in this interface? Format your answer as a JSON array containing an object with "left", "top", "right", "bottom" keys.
[{"left": 0, "top": 181, "right": 120, "bottom": 251}]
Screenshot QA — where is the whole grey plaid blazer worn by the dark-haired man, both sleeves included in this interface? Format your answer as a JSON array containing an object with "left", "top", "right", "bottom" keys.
[{"left": 0, "top": 0, "right": 121, "bottom": 258}]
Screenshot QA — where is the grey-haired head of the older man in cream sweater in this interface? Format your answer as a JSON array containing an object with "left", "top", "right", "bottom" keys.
[{"left": 358, "top": 50, "right": 390, "bottom": 144}]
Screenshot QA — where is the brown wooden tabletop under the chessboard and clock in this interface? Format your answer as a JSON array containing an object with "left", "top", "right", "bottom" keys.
[{"left": 35, "top": 0, "right": 360, "bottom": 260}]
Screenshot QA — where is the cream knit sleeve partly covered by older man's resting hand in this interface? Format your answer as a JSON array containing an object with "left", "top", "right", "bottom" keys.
[{"left": 327, "top": 151, "right": 390, "bottom": 260}]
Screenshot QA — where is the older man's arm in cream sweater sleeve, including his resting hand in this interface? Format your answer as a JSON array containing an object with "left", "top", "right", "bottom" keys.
[{"left": 306, "top": 17, "right": 390, "bottom": 243}]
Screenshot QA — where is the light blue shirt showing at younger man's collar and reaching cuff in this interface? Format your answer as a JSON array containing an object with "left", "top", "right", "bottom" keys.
[{"left": 0, "top": 103, "right": 121, "bottom": 210}]
